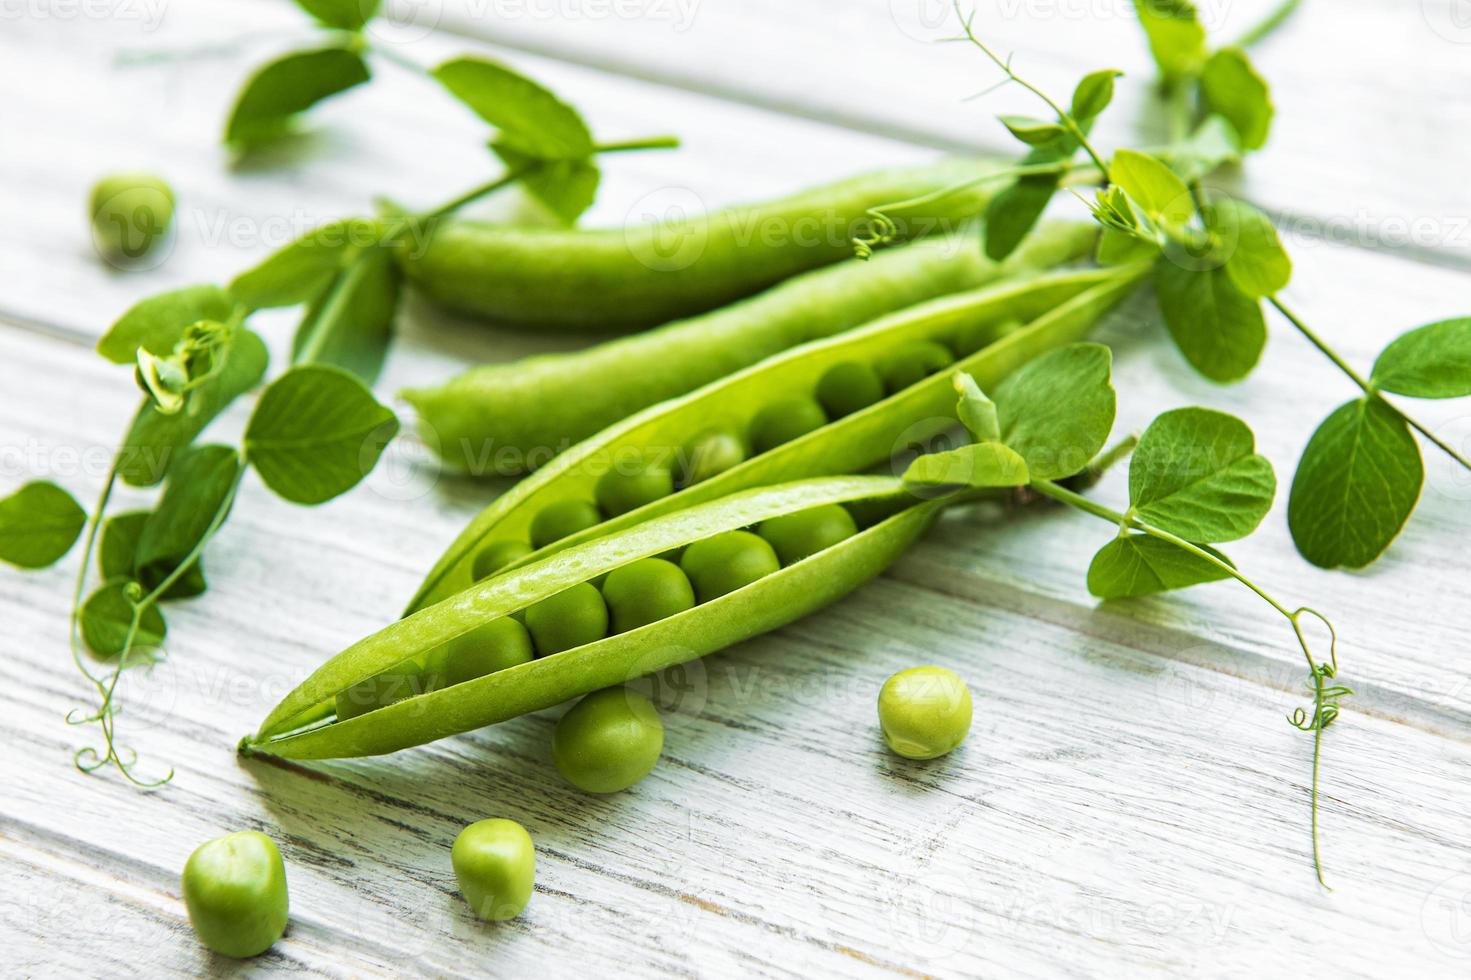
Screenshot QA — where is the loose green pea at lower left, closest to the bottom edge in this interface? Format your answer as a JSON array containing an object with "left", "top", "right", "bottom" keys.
[{"left": 182, "top": 830, "right": 287, "bottom": 959}]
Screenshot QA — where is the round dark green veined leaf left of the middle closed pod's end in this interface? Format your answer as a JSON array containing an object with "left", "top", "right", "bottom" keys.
[{"left": 246, "top": 365, "right": 399, "bottom": 503}]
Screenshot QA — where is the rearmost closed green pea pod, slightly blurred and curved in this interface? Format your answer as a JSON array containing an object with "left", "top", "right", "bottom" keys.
[{"left": 400, "top": 157, "right": 1008, "bottom": 333}]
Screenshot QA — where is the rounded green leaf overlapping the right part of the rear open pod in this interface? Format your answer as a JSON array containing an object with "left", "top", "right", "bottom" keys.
[{"left": 993, "top": 344, "right": 1115, "bottom": 480}]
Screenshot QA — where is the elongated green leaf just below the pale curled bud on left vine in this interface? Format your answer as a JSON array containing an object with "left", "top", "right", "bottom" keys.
[{"left": 118, "top": 327, "right": 268, "bottom": 487}]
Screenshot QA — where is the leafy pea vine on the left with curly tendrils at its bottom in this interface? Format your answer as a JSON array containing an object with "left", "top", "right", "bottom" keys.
[{"left": 0, "top": 59, "right": 675, "bottom": 787}]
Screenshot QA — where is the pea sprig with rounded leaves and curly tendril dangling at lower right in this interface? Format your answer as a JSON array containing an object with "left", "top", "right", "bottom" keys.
[{"left": 903, "top": 353, "right": 1352, "bottom": 883}]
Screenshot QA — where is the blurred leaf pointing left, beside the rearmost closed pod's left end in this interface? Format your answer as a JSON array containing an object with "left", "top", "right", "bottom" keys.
[{"left": 229, "top": 218, "right": 384, "bottom": 310}]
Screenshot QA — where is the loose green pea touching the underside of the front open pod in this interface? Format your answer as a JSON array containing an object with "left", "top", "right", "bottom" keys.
[{"left": 552, "top": 687, "right": 663, "bottom": 793}]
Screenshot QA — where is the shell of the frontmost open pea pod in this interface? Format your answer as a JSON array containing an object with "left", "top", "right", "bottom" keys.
[{"left": 241, "top": 477, "right": 947, "bottom": 759}]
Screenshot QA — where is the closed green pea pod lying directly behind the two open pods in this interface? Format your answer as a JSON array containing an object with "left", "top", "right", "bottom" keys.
[{"left": 403, "top": 222, "right": 1096, "bottom": 474}]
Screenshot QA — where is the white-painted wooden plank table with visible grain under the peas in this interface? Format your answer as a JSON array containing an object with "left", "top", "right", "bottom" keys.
[{"left": 0, "top": 0, "right": 1471, "bottom": 977}]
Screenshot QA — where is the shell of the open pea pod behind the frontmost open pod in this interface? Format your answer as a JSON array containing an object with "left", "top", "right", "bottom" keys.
[{"left": 409, "top": 258, "right": 1147, "bottom": 612}]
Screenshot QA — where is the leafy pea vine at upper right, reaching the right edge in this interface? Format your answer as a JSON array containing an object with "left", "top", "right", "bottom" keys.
[{"left": 855, "top": 0, "right": 1471, "bottom": 568}]
